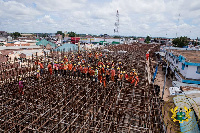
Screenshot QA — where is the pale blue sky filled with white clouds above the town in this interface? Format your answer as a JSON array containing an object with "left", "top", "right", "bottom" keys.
[{"left": 0, "top": 0, "right": 200, "bottom": 38}]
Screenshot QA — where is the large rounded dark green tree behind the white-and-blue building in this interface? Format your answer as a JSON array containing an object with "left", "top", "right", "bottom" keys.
[{"left": 172, "top": 36, "right": 189, "bottom": 48}]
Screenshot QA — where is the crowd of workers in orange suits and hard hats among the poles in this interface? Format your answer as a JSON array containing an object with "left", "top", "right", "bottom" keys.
[{"left": 20, "top": 52, "right": 139, "bottom": 95}]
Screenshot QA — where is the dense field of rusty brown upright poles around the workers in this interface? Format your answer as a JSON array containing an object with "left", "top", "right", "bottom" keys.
[{"left": 0, "top": 45, "right": 163, "bottom": 133}]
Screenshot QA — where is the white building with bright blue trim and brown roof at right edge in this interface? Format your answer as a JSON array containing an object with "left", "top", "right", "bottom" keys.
[{"left": 165, "top": 49, "right": 200, "bottom": 84}]
